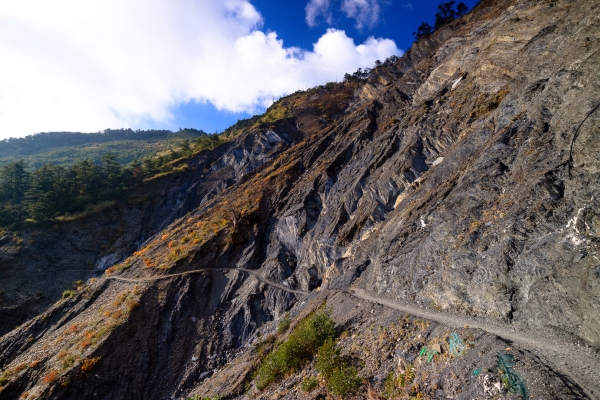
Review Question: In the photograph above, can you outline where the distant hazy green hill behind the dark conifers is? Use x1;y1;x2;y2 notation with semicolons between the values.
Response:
0;129;205;169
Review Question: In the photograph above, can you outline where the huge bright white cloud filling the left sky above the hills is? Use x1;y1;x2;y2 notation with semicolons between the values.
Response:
0;0;401;138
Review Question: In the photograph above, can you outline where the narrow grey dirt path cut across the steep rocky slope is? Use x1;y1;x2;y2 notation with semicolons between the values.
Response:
106;268;600;399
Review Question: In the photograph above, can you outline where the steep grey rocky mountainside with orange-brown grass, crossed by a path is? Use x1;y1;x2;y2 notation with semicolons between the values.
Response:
0;0;600;400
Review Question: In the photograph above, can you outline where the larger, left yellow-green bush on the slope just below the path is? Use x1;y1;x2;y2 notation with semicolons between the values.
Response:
256;309;335;390
